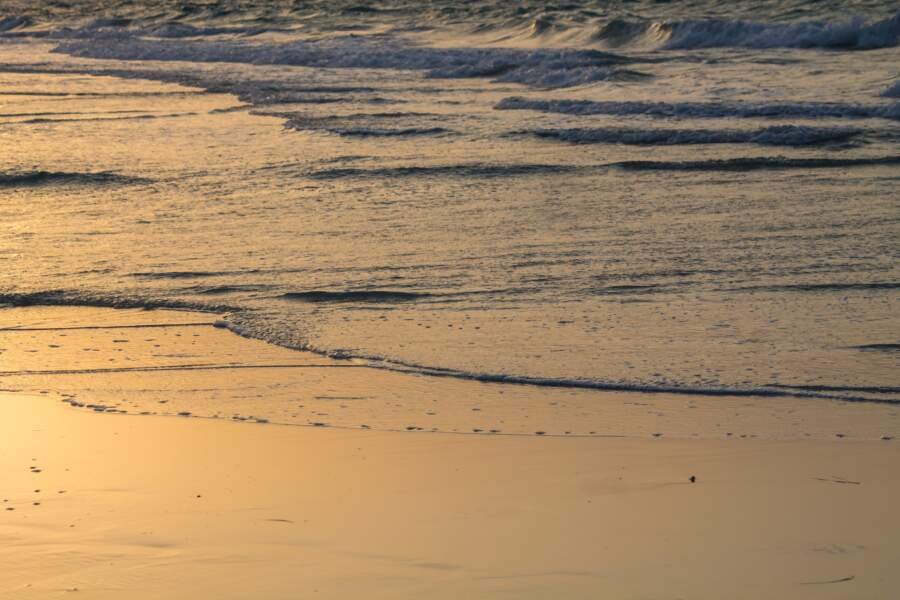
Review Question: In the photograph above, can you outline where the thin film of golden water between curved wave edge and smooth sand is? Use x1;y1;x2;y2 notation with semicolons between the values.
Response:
0;306;900;441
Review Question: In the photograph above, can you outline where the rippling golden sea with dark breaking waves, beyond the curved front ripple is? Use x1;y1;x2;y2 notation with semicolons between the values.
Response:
0;0;900;402
